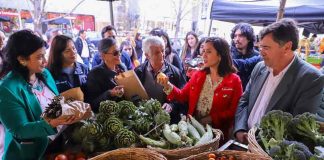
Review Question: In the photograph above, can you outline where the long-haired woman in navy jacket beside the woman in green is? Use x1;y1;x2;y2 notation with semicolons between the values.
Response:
47;35;89;93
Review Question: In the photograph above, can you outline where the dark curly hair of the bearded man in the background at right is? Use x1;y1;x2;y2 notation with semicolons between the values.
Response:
231;23;255;53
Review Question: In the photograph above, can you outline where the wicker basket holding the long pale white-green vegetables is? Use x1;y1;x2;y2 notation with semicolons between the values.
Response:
148;129;223;160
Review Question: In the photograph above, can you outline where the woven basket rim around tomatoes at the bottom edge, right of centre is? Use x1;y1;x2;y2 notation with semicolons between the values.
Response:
181;150;271;160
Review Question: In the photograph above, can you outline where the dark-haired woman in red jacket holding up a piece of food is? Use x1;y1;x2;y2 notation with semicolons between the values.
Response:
157;37;242;140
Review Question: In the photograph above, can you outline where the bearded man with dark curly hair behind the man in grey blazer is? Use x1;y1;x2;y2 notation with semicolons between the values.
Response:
231;23;261;89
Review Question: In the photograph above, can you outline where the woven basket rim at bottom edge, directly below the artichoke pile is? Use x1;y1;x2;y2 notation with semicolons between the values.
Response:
89;148;167;160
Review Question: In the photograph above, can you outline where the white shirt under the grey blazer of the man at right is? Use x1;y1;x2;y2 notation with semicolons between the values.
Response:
248;57;295;128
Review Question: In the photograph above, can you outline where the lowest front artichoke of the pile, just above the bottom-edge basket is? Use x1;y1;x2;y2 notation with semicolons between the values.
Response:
114;129;136;148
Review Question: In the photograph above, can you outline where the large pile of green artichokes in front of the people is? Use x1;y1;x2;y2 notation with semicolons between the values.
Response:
67;99;170;154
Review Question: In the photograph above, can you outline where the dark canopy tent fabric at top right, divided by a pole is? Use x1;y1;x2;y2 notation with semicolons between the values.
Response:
210;0;324;33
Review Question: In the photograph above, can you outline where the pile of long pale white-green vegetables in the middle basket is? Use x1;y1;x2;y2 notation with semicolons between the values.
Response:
139;116;213;149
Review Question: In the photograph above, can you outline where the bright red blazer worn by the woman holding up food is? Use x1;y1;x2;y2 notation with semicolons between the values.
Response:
167;71;243;139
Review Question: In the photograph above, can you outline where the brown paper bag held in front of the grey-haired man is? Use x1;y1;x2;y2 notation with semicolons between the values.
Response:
115;70;148;100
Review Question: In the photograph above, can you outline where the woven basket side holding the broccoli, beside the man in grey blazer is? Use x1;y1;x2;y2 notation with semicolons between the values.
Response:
248;127;269;157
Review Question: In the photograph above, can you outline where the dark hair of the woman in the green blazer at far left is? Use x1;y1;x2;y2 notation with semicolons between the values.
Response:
4;30;46;82
